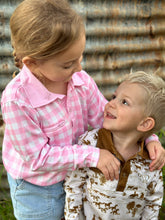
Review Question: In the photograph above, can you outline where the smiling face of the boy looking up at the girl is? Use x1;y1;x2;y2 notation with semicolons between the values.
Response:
103;82;145;133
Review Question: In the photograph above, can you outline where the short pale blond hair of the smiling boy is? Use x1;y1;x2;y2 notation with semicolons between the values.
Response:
124;71;165;137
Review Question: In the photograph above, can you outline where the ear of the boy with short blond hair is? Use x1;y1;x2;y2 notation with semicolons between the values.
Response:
137;117;155;132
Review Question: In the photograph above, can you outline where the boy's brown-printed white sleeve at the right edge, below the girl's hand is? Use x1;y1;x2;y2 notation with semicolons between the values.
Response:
142;170;163;220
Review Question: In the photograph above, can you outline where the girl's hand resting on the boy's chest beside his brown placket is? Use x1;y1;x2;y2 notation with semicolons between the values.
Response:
97;149;120;180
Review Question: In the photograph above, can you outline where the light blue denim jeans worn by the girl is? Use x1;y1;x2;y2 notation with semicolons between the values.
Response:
8;174;65;220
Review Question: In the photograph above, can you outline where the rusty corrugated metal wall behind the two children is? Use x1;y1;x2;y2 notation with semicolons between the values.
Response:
0;0;165;199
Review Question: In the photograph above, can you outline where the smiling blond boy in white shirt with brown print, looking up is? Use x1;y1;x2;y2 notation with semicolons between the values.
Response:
65;72;165;220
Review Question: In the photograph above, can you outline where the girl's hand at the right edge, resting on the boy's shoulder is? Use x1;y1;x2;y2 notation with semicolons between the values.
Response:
147;141;165;171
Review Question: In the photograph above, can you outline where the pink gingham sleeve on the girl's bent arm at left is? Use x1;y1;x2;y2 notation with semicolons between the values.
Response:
3;102;99;174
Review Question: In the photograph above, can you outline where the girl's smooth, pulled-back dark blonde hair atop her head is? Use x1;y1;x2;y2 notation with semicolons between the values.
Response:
10;0;85;59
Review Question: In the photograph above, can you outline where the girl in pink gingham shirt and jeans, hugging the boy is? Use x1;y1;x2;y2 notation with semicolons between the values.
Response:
1;0;164;220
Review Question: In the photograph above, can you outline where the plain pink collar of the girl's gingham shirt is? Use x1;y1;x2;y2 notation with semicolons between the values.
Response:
20;65;83;108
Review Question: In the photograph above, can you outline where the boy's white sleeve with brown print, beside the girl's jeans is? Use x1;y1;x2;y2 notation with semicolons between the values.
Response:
64;168;86;220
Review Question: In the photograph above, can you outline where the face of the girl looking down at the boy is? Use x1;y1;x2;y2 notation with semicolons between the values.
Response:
33;35;85;83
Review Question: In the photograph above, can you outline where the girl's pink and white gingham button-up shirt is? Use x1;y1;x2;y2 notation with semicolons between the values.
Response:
1;66;107;186
